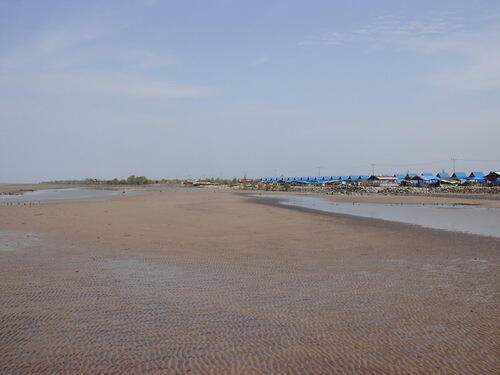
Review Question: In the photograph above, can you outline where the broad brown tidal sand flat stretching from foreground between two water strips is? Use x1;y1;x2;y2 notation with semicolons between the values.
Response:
0;189;500;374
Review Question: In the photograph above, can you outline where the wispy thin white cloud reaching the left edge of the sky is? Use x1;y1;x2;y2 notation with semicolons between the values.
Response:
0;28;212;99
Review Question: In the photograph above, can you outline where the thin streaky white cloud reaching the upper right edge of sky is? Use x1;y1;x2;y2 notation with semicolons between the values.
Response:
300;15;500;91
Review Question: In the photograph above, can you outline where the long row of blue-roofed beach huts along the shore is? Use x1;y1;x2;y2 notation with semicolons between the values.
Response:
260;171;500;186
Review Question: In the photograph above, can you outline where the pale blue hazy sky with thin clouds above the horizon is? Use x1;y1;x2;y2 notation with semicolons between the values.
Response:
0;0;500;182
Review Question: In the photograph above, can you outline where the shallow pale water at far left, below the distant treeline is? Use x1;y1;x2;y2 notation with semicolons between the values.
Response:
0;187;125;205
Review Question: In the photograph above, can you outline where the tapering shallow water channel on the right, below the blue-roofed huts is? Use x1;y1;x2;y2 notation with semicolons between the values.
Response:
253;194;500;237
